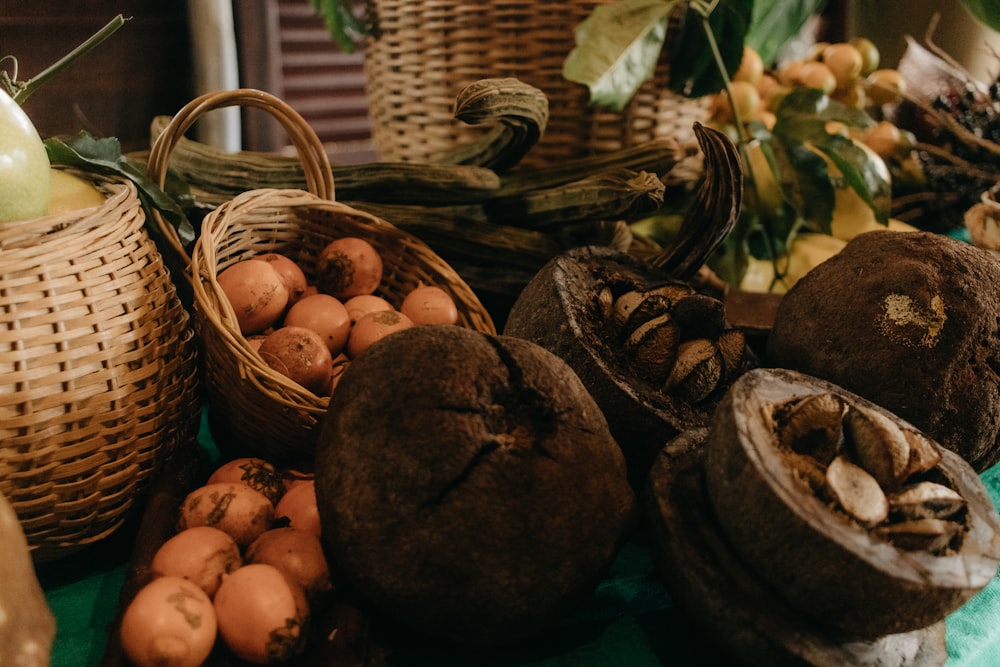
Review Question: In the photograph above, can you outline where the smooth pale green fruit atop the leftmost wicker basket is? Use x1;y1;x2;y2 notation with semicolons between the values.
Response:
0;90;50;222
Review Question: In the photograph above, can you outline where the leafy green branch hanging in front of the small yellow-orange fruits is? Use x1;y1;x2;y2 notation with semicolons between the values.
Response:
563;0;891;284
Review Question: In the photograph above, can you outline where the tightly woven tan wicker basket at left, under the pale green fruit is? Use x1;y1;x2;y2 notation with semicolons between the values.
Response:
0;170;201;562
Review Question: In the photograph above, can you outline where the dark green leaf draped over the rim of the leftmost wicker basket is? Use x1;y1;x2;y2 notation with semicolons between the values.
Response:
45;132;195;245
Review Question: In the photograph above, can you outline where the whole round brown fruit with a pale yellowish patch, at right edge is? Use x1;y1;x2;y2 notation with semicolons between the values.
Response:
766;231;1000;472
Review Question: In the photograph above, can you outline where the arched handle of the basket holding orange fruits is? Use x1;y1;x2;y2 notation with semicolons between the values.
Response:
146;88;334;264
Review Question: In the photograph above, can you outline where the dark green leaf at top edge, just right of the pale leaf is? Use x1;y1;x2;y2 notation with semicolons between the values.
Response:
669;0;754;97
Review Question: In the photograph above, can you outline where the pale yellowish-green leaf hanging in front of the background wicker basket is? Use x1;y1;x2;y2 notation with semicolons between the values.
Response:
563;0;679;111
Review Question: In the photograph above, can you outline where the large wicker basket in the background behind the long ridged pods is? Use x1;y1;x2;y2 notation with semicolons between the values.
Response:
364;0;709;166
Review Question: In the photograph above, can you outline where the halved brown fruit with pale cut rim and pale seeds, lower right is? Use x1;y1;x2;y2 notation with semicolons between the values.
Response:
704;369;1000;640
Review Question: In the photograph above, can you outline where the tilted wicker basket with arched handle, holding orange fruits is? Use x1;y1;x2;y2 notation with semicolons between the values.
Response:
148;89;496;465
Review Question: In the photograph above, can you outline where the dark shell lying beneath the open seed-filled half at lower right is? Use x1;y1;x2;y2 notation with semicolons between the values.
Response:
644;428;948;667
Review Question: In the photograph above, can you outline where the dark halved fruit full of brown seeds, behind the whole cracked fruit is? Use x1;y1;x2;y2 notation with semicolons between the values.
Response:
504;246;757;488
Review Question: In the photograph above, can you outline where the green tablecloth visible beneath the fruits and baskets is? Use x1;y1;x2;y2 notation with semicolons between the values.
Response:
39;428;1000;667
